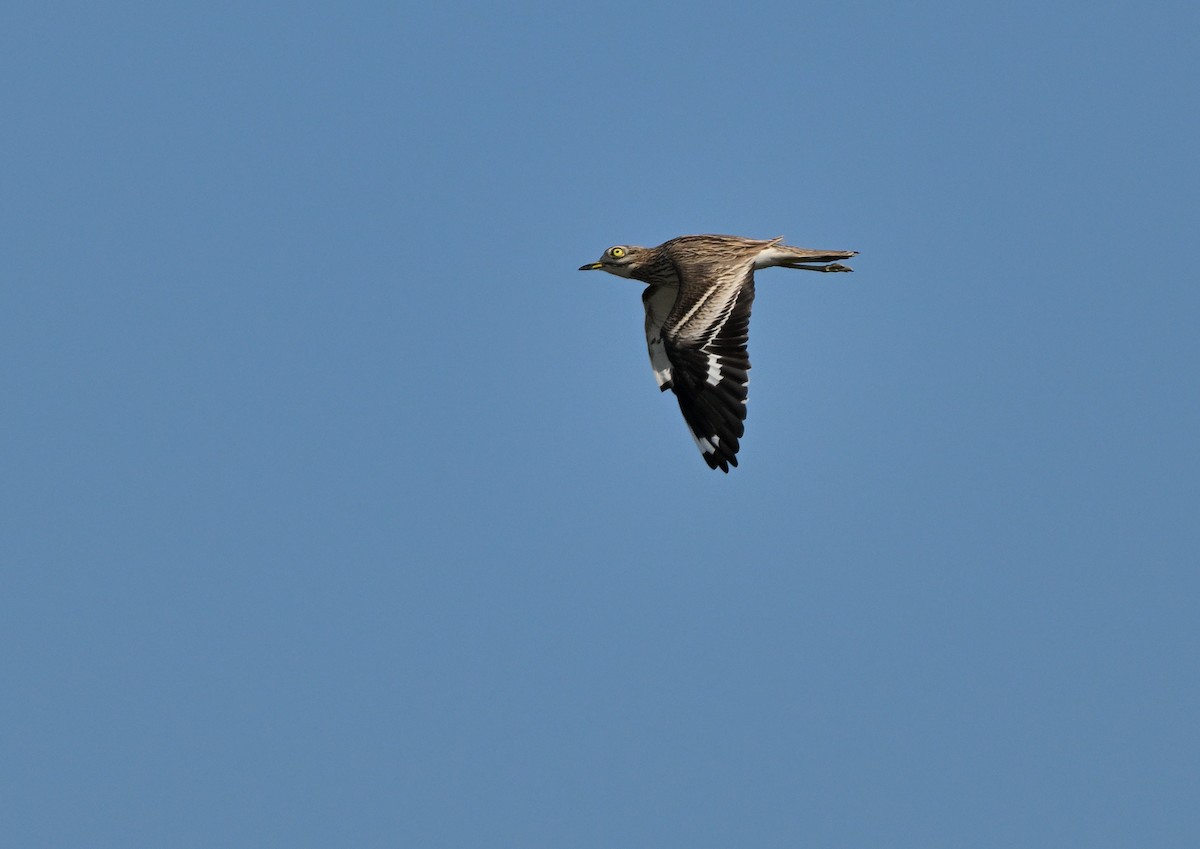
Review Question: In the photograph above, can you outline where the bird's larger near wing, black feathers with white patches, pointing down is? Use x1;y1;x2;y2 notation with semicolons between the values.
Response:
662;257;754;472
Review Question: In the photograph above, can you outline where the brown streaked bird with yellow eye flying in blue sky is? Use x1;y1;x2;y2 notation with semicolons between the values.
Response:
580;234;858;474
